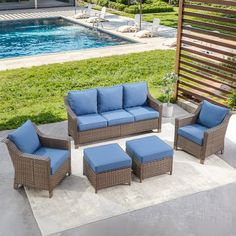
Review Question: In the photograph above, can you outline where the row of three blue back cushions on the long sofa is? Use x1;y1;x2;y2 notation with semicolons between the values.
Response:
67;82;148;116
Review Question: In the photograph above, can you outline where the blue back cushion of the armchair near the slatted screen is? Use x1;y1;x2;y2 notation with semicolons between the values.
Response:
197;100;229;128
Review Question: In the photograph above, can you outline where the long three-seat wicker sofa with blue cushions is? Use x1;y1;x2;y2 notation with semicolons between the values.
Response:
64;82;162;148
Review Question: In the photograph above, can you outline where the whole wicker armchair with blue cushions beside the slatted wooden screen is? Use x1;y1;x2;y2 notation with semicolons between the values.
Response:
174;101;232;164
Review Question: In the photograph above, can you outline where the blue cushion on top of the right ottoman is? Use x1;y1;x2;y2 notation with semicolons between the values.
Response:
126;135;173;164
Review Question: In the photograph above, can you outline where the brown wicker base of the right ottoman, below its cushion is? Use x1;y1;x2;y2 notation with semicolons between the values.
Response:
132;157;173;183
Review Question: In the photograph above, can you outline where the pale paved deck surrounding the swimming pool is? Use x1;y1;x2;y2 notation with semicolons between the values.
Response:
0;7;176;71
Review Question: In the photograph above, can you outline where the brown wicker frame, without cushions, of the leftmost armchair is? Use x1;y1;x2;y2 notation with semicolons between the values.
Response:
2;125;71;198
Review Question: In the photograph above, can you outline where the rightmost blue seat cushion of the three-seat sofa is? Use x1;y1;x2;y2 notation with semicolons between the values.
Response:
125;106;159;121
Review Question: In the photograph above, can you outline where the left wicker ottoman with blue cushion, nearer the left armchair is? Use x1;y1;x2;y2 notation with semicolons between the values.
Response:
83;144;132;193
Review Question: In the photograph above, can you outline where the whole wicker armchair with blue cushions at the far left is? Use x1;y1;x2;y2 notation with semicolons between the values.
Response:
3;120;71;198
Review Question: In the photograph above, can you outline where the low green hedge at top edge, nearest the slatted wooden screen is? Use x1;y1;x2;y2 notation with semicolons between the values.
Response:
124;2;173;14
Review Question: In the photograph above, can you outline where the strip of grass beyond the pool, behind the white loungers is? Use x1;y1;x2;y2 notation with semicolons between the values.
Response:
93;6;178;28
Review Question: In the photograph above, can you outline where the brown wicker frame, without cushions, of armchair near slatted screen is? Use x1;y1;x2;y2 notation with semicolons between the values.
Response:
174;103;232;164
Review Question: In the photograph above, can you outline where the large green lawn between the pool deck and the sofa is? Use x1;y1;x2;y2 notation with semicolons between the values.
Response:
0;50;175;130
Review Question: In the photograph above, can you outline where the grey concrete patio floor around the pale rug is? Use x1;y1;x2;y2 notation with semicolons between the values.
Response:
0;106;236;236
